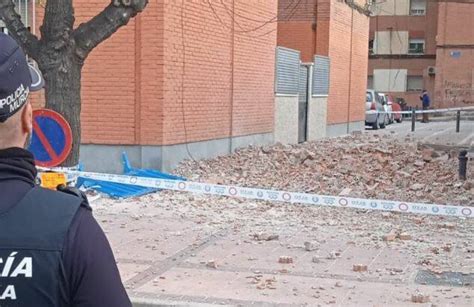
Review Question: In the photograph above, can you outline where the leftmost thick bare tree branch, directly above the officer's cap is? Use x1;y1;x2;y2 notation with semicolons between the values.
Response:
0;0;40;60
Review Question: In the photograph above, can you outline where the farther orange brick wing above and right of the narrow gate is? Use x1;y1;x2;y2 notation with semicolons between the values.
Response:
277;0;369;136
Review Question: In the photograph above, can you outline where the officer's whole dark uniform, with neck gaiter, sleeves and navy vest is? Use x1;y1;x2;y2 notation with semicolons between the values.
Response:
0;148;131;307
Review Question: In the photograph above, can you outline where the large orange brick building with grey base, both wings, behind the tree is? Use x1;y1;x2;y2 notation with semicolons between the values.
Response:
0;0;369;172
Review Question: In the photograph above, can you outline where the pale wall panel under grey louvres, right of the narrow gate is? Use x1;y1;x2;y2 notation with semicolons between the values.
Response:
306;96;328;141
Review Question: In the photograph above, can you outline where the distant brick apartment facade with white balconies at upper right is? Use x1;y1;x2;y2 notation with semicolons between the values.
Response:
367;0;474;108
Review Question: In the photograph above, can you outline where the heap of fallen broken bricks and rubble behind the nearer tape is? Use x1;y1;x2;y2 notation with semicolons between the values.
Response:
177;134;474;205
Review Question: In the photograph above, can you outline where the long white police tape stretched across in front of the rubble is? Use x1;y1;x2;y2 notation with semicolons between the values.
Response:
41;169;474;218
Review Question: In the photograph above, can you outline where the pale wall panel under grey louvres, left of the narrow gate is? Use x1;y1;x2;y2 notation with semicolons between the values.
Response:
274;95;298;144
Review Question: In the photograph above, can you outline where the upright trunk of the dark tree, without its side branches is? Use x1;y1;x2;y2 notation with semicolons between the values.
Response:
36;0;83;166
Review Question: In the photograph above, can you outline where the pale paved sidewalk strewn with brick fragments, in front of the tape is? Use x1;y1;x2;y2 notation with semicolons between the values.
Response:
97;199;474;306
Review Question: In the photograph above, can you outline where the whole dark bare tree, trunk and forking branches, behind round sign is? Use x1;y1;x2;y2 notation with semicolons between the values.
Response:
0;0;148;166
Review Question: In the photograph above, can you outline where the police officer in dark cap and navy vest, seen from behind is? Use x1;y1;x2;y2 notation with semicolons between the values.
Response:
0;34;131;307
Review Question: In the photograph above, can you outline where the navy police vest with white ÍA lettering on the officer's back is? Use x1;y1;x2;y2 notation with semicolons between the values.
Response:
0;187;82;307
